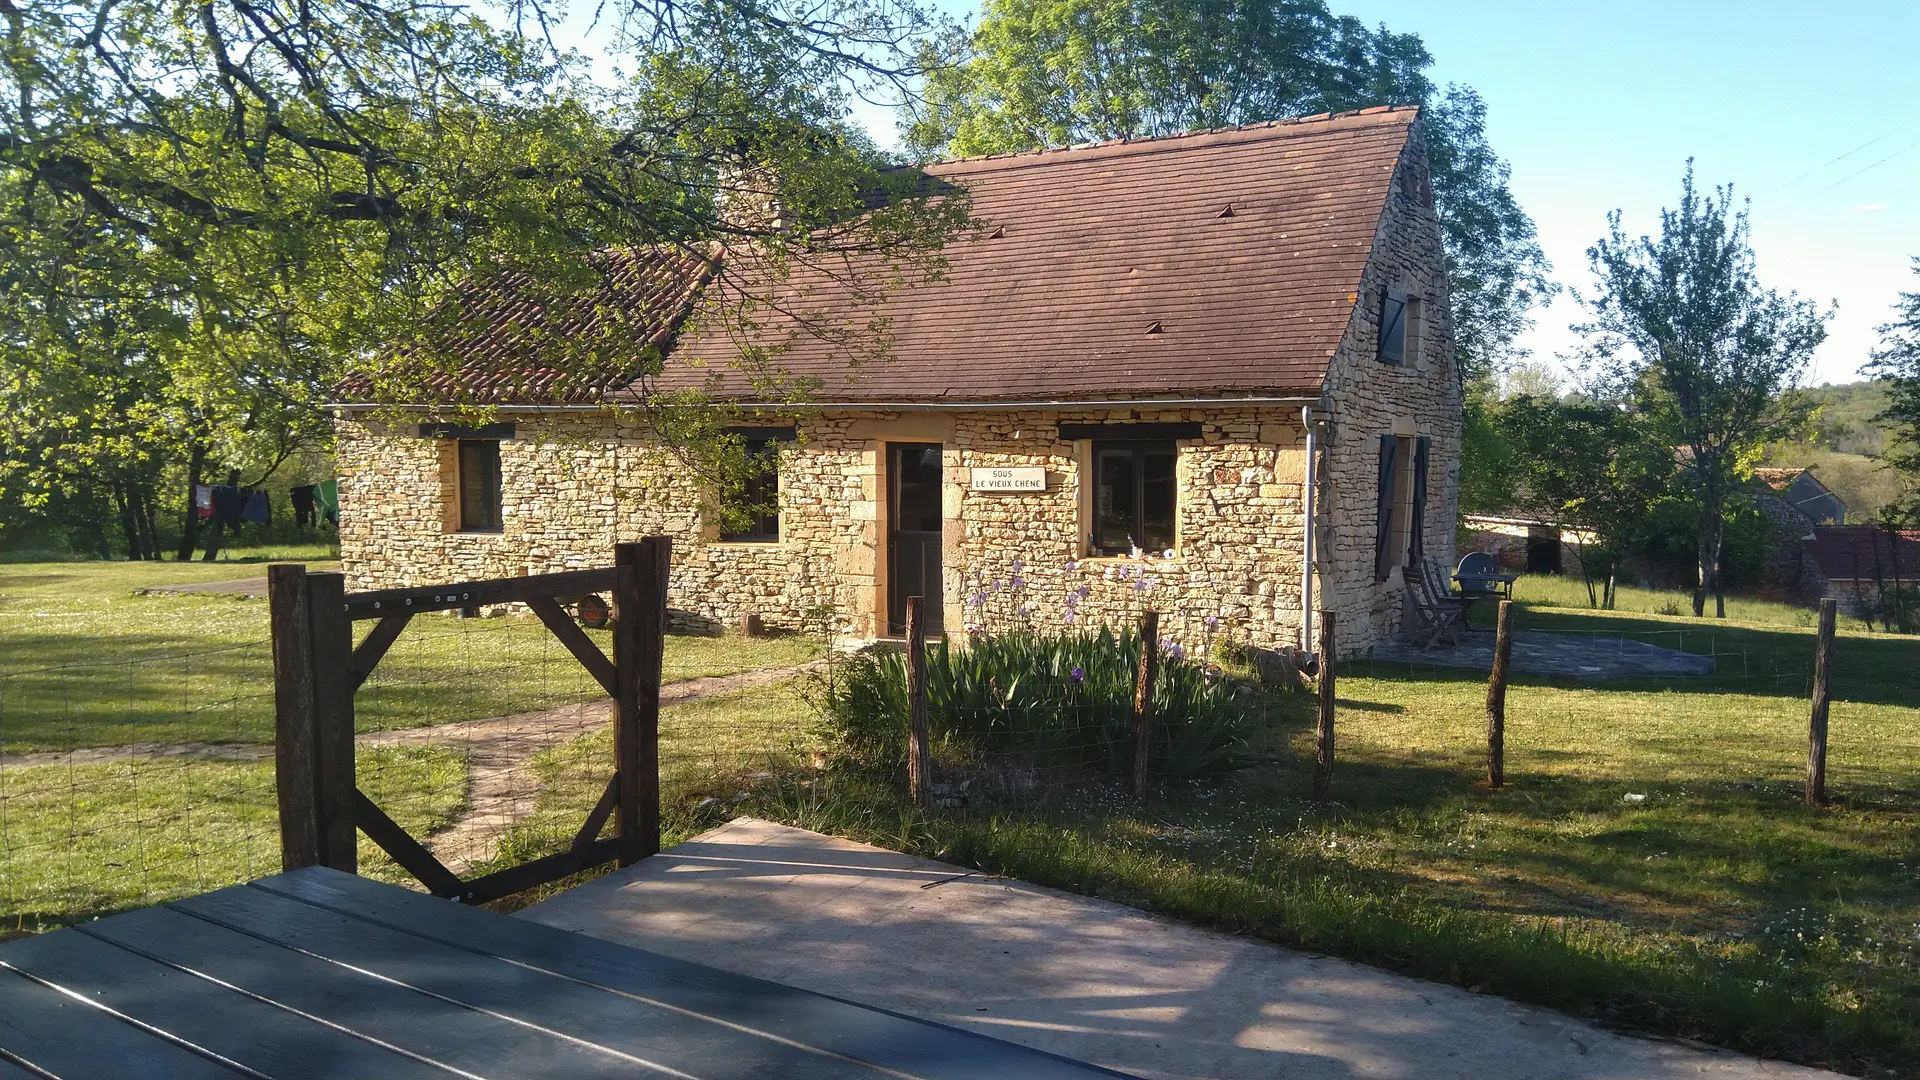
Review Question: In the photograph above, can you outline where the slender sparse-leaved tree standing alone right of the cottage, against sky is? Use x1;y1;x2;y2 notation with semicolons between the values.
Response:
1576;161;1832;619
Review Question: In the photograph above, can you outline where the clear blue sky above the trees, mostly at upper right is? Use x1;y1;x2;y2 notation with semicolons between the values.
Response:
560;0;1920;382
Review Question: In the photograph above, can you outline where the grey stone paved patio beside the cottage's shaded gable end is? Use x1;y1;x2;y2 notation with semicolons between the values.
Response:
1373;630;1713;682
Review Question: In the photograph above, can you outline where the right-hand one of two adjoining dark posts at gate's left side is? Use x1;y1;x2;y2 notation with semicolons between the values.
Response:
307;575;359;874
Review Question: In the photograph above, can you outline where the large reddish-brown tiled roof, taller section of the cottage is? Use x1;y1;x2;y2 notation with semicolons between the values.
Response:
662;108;1417;402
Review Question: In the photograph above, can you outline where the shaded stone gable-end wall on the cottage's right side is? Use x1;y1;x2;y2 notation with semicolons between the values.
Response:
1315;125;1461;653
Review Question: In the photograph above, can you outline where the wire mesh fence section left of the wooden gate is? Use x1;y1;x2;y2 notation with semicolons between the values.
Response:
0;640;280;934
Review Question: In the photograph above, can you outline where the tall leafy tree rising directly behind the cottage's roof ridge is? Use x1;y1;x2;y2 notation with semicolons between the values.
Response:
904;0;1555;382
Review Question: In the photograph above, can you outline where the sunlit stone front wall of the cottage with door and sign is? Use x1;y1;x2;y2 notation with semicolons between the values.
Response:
338;407;1304;648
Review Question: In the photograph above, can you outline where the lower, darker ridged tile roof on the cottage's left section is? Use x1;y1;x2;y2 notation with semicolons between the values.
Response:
334;248;708;405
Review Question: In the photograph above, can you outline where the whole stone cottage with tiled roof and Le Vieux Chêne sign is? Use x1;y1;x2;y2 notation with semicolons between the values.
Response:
334;108;1461;653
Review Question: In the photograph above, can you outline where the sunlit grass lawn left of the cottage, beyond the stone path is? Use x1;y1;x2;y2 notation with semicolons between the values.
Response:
0;563;818;753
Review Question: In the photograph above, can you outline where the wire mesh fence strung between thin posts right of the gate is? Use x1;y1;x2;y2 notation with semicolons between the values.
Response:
798;595;1920;809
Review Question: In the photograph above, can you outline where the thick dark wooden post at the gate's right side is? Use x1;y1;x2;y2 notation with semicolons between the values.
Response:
612;536;674;867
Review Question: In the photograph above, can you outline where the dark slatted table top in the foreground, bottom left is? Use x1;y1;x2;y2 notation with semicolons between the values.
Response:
0;869;1121;1080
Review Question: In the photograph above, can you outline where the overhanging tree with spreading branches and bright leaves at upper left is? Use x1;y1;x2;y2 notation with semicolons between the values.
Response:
0;0;966;552
